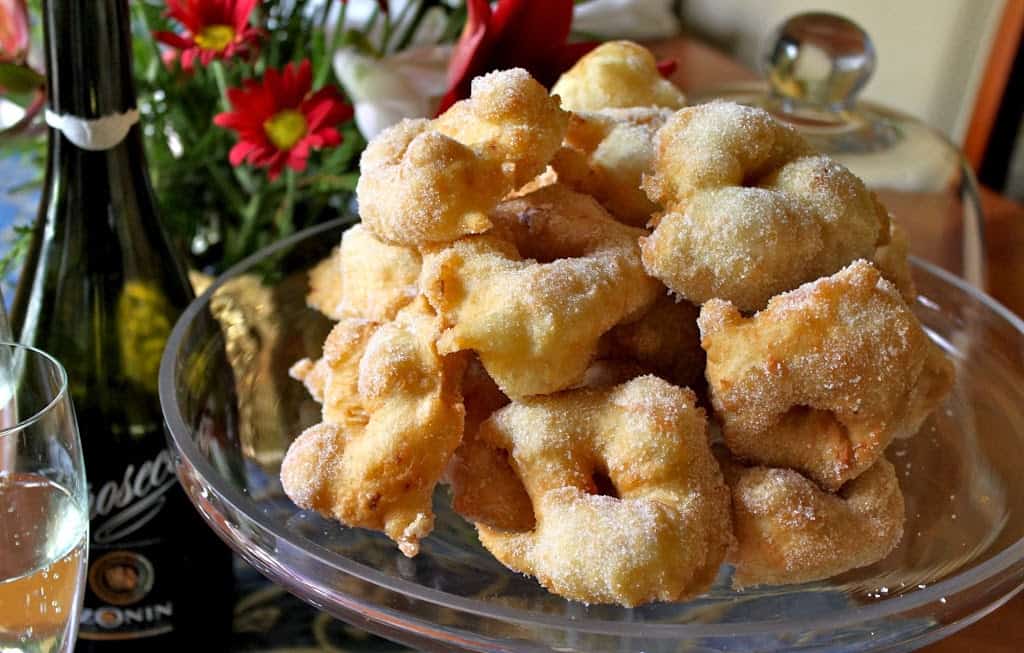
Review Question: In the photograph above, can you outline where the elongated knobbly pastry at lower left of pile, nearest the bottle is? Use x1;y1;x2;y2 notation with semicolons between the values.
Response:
281;300;465;556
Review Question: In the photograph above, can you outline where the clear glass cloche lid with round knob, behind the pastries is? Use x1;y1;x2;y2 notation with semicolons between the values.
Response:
691;12;985;287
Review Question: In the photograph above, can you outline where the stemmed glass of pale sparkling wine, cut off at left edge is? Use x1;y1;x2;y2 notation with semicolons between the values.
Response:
0;342;89;653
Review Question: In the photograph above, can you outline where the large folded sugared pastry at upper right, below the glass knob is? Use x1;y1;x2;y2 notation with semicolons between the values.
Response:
641;101;889;311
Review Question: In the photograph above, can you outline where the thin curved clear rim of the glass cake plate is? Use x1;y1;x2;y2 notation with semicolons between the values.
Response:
159;215;1024;639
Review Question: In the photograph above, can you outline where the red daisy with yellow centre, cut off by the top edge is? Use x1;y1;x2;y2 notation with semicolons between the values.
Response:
153;0;260;71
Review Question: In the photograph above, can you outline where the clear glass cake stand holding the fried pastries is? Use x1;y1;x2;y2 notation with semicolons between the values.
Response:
160;219;1024;653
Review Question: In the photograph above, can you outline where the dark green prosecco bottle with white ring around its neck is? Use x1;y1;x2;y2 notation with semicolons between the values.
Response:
11;0;231;653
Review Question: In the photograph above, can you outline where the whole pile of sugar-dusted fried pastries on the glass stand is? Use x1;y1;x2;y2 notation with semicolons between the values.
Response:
282;42;952;606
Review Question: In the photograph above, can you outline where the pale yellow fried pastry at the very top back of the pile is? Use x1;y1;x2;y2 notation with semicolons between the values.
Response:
551;41;686;112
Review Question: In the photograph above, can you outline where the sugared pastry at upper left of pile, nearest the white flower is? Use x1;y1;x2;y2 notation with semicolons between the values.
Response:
356;69;568;246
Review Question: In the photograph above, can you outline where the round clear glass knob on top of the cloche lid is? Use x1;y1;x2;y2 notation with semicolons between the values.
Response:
762;12;874;112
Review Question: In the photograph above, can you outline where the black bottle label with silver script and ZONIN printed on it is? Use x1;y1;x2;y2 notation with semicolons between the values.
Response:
79;449;177;640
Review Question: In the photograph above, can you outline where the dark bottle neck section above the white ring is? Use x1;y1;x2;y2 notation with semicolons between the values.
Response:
43;0;135;118
